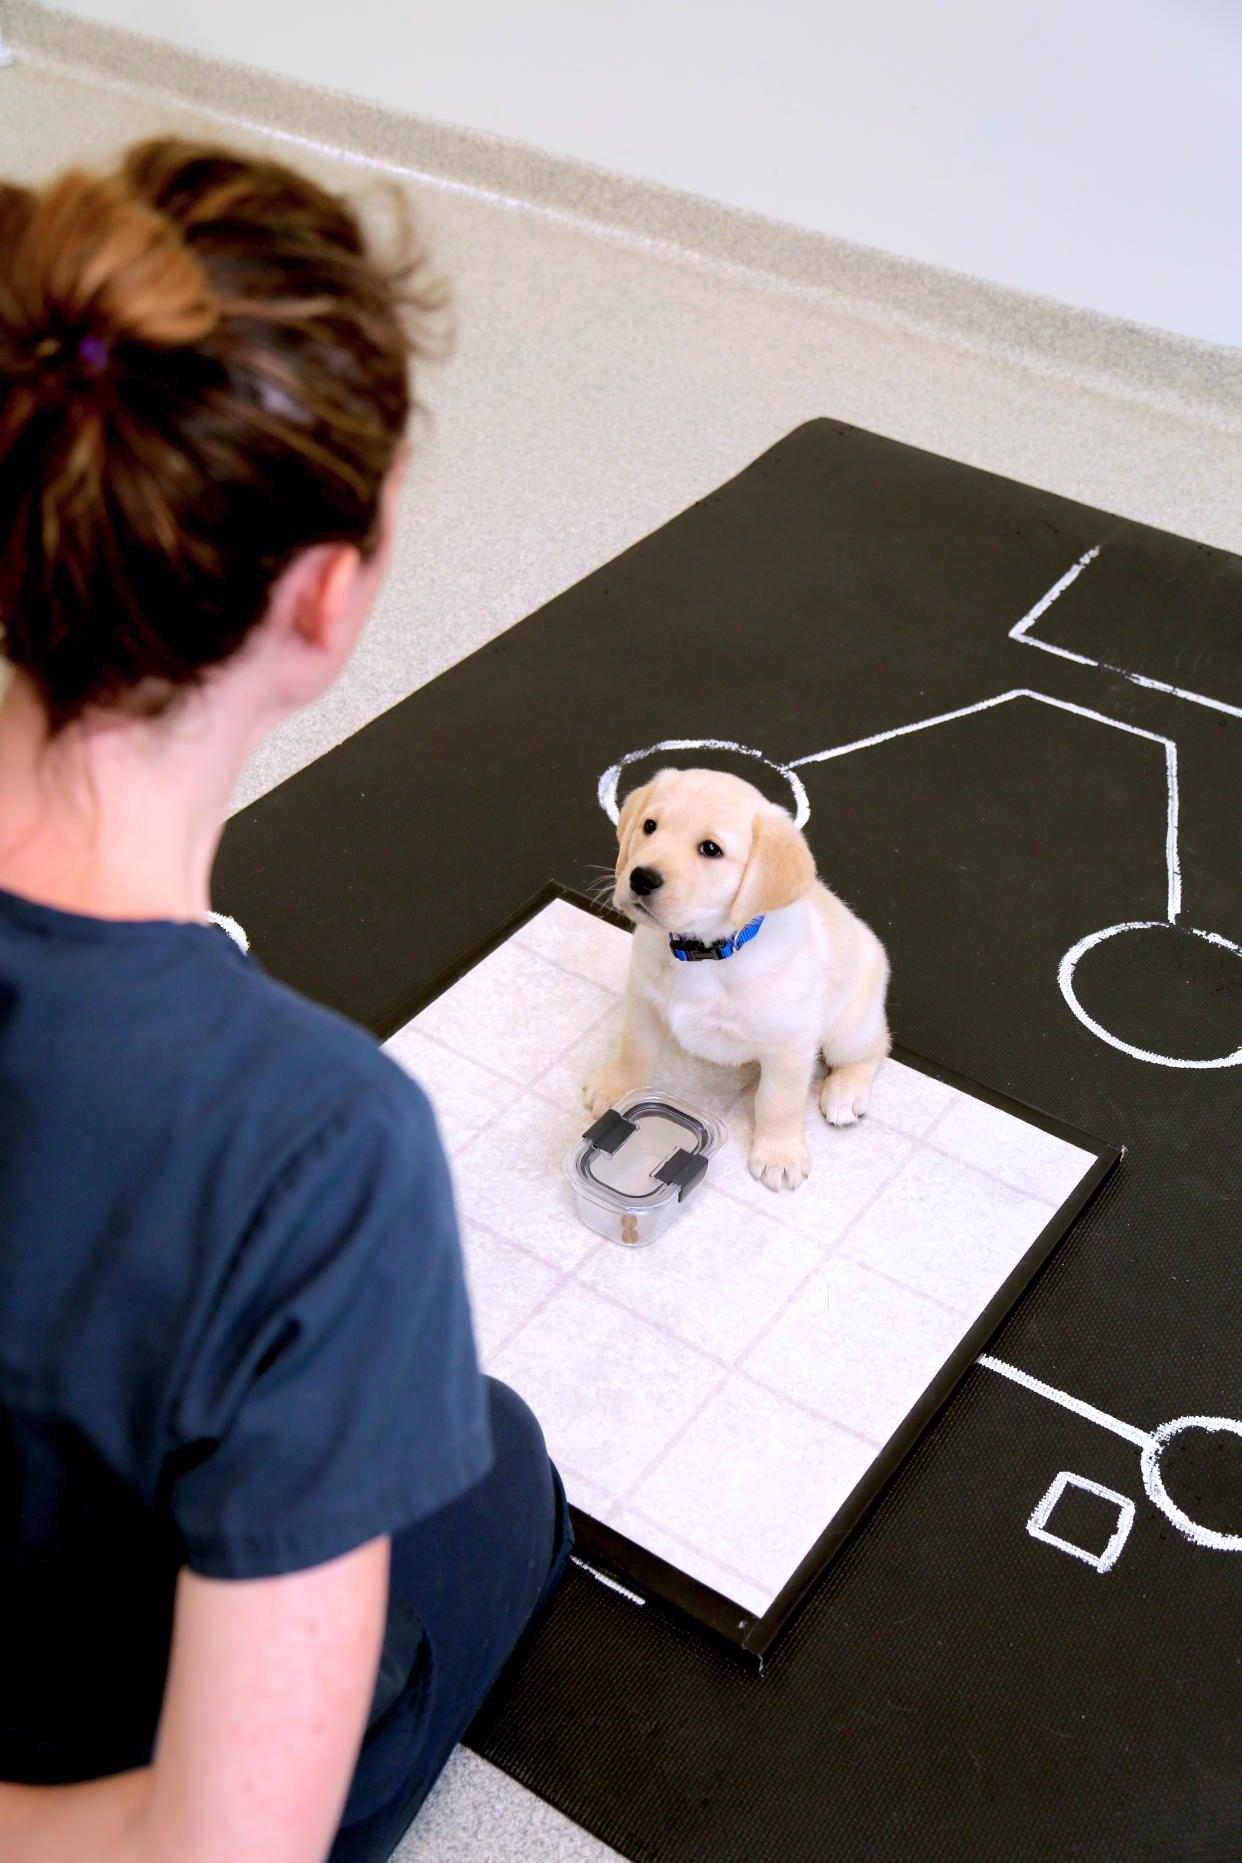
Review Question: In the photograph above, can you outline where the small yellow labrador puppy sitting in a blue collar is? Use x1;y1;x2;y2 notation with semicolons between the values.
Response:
583;769;888;1190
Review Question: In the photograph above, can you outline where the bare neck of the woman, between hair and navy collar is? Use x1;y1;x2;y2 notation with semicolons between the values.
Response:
0;673;258;920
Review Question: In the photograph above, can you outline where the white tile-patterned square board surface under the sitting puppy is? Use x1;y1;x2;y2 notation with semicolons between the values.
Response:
385;900;1095;1617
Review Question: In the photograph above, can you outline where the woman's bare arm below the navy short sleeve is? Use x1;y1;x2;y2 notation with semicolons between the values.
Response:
140;1539;389;1863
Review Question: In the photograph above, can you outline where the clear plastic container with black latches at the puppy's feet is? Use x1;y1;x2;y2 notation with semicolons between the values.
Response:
564;1088;728;1248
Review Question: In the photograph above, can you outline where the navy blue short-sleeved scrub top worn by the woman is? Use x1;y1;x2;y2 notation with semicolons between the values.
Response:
0;892;492;1783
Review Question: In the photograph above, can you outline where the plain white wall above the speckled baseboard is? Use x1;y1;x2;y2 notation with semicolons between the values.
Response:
33;0;1242;343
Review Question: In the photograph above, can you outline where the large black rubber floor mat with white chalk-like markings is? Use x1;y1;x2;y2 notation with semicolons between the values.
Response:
216;421;1242;1863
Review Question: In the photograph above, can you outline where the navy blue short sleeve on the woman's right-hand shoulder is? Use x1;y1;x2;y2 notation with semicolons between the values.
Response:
166;1069;492;1578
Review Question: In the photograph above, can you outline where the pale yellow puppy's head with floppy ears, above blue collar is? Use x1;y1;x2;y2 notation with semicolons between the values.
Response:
613;769;816;945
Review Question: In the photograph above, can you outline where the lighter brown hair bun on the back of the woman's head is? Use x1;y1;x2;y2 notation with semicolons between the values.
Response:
4;170;220;361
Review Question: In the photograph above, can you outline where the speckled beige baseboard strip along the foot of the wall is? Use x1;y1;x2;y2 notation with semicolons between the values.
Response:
9;0;1242;432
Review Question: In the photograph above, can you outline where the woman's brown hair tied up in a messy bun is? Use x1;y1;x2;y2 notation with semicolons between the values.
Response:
0;140;447;732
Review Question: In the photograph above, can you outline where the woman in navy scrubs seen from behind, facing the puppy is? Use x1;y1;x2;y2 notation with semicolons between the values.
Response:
0;142;568;1863
